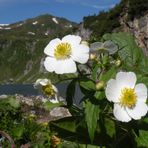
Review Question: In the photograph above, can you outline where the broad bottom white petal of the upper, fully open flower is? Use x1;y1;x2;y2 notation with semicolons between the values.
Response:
55;58;77;74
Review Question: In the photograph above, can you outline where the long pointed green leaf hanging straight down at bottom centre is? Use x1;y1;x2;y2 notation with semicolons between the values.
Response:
84;100;100;142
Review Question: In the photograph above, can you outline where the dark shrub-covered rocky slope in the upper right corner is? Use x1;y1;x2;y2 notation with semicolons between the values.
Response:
83;0;148;55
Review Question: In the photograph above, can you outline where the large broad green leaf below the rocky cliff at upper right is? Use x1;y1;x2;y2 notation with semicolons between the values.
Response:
103;32;144;71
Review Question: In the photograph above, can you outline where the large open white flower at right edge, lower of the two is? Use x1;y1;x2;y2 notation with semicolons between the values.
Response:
105;72;148;122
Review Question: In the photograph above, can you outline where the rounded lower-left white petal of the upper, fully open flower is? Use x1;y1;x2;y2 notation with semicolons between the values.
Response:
44;57;56;72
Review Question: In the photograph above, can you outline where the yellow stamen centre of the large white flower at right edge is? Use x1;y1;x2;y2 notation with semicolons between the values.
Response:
120;88;137;108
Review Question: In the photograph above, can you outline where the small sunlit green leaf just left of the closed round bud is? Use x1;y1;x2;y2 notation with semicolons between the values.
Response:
80;78;96;91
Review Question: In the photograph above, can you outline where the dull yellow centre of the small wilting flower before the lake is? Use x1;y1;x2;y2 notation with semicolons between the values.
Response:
42;84;55;97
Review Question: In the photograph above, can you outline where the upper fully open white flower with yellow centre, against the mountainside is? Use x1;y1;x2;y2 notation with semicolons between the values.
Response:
44;35;89;74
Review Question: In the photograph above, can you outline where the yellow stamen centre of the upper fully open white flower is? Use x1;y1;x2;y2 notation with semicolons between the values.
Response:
54;43;71;60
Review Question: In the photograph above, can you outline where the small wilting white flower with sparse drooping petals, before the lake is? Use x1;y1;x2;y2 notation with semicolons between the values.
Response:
34;79;59;103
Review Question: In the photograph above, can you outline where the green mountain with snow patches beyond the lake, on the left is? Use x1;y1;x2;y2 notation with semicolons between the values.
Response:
0;14;77;83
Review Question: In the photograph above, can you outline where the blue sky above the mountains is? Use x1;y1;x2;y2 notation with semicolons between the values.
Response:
0;0;120;24
